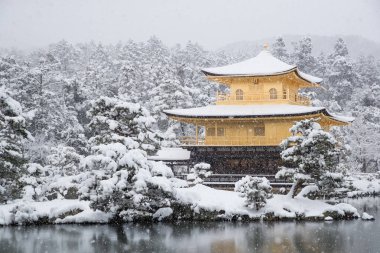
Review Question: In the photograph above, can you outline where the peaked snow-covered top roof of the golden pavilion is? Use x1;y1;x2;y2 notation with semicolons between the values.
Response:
202;50;322;83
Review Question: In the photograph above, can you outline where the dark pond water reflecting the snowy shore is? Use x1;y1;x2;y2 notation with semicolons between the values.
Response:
0;198;380;253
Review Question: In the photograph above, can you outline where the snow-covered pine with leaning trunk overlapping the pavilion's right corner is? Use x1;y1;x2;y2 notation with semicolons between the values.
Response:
276;119;341;198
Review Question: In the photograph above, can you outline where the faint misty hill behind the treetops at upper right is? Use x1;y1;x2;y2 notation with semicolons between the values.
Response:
218;35;380;59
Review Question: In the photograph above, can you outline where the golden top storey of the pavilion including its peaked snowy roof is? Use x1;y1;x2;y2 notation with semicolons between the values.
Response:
202;49;322;105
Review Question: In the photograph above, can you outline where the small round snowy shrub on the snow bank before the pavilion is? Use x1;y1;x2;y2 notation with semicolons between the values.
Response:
235;176;273;210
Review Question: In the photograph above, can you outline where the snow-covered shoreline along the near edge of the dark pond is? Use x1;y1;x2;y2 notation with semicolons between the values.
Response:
0;185;376;225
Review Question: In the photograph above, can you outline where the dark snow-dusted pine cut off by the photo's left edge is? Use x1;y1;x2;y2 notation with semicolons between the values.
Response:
0;87;31;202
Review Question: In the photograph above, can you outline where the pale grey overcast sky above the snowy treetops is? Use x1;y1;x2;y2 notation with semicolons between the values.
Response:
0;0;380;49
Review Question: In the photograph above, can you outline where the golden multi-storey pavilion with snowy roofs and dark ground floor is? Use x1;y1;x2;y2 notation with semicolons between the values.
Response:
164;48;353;174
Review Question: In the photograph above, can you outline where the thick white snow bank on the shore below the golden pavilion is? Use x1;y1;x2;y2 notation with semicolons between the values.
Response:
177;185;359;218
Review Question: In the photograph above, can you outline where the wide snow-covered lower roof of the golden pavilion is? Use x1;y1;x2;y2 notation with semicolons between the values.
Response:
164;104;354;123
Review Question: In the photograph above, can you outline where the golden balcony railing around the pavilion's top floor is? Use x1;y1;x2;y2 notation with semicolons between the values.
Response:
216;92;310;105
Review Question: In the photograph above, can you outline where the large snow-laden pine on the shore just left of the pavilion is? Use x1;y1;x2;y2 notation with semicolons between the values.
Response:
83;97;173;220
